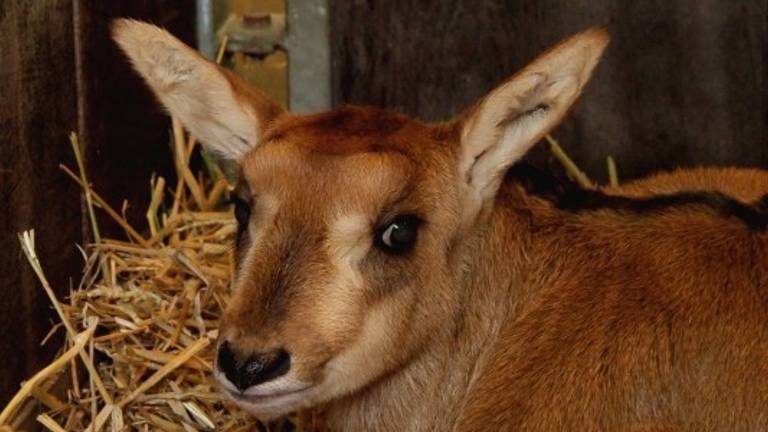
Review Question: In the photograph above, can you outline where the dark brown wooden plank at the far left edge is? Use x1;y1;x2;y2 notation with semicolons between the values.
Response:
0;0;81;406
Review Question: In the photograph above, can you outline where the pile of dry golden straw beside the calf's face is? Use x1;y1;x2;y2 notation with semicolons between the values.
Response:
0;121;314;432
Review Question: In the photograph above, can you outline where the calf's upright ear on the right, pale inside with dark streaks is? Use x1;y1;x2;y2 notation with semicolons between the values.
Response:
458;28;609;219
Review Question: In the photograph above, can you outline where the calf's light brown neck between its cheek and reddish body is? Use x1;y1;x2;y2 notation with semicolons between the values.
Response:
325;197;532;431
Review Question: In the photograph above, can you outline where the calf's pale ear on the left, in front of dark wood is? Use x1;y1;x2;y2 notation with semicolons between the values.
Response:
112;19;283;164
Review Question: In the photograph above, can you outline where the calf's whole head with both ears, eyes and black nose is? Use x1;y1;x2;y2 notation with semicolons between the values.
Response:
113;20;607;417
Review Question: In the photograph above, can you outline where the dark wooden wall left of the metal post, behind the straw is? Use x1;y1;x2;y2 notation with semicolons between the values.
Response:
0;0;194;406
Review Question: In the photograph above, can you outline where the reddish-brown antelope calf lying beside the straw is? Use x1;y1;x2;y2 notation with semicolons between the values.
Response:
114;20;768;431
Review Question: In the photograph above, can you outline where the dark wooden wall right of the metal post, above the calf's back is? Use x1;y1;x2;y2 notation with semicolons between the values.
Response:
331;0;768;182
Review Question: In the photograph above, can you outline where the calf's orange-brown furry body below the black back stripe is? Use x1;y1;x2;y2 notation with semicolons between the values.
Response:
459;176;768;430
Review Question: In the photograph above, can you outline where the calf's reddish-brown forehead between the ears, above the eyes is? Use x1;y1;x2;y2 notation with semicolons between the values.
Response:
241;107;435;218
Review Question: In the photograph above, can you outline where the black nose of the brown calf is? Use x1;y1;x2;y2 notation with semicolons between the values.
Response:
218;342;291;391
